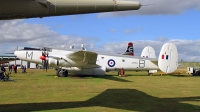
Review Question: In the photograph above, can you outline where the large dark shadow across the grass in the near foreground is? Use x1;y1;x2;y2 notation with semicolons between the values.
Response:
0;89;200;112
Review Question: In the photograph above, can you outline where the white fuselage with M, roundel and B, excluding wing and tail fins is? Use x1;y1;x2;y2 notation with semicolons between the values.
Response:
15;49;159;71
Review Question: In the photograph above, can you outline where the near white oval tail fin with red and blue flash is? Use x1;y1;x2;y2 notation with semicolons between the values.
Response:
158;43;178;73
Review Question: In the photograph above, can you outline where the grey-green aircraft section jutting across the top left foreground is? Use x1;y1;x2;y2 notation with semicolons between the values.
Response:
0;0;141;20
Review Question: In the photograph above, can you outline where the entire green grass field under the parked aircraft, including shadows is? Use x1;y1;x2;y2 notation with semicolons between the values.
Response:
0;70;200;112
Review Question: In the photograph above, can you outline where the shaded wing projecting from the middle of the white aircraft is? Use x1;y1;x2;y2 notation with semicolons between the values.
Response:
66;51;99;68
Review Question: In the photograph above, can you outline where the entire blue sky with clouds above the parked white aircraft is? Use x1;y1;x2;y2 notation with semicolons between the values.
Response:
0;0;200;61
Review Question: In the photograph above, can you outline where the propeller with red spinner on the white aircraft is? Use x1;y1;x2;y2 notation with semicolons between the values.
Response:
40;48;49;72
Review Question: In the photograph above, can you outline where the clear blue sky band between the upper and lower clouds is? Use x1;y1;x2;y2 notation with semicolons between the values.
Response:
24;9;200;44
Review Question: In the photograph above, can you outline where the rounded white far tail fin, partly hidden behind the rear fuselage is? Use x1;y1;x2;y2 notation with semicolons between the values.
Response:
141;46;156;58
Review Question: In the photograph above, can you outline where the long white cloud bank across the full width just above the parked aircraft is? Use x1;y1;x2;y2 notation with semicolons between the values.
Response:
0;20;200;61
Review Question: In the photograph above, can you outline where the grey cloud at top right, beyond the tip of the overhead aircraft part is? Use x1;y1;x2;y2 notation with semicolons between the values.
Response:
97;0;200;18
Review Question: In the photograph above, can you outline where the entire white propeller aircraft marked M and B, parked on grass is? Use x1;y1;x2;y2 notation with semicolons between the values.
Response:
14;43;178;76
